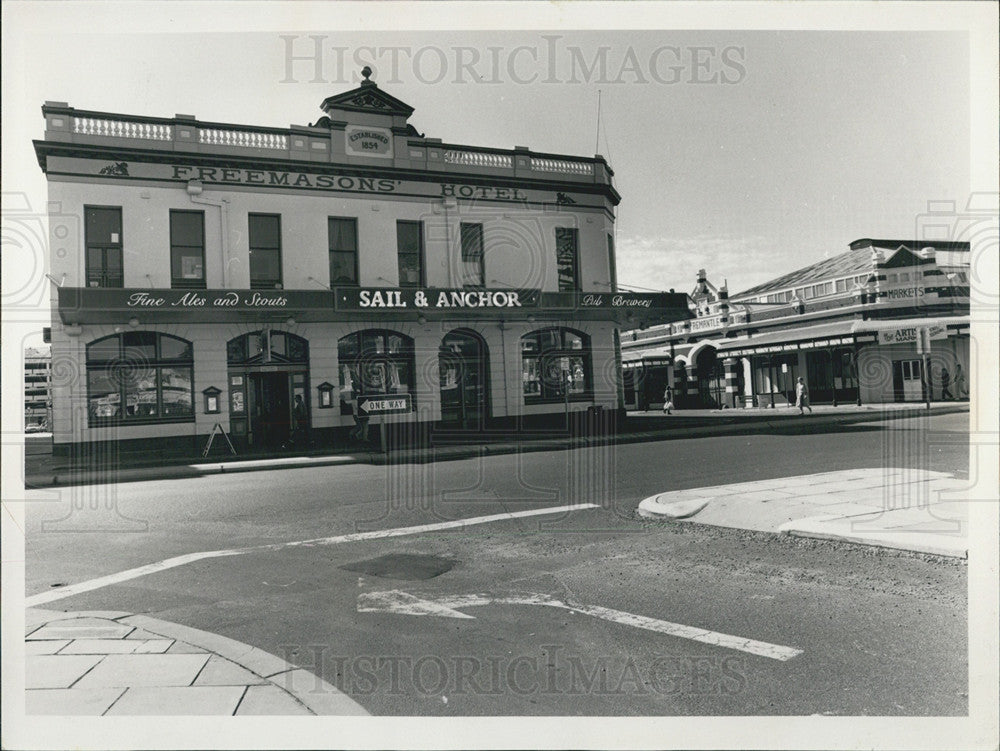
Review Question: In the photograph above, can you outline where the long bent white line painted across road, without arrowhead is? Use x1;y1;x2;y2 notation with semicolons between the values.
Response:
24;503;600;607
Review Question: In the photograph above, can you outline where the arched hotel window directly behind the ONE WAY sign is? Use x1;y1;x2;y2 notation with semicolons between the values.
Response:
337;329;415;415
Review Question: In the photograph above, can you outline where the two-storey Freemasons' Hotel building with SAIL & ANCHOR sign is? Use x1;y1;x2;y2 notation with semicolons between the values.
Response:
34;71;688;451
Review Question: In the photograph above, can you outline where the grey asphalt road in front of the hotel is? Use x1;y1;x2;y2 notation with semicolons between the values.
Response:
26;415;968;715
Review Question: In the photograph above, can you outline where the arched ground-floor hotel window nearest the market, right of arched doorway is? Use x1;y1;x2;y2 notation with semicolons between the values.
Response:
521;328;593;403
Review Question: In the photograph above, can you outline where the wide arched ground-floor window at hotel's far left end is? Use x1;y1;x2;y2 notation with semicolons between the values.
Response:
87;331;194;426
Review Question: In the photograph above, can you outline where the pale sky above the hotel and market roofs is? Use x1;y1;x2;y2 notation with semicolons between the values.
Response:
3;2;988;350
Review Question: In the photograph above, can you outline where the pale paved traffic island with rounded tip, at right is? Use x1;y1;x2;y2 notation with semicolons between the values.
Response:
637;467;969;558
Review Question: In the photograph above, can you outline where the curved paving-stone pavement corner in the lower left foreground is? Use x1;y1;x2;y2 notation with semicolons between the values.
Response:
25;608;368;716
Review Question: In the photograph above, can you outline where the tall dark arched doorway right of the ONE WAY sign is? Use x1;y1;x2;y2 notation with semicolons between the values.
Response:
438;329;489;430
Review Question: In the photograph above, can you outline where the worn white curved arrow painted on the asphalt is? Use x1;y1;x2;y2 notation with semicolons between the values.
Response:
358;589;802;661
